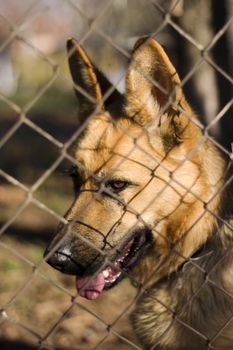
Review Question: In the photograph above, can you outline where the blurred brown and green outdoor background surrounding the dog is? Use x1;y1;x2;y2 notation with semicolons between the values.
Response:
0;0;233;350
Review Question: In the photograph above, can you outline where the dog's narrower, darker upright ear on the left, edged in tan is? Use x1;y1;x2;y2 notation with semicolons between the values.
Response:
67;38;122;119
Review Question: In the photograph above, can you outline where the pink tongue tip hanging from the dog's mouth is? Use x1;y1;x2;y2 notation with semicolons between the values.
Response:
76;272;105;300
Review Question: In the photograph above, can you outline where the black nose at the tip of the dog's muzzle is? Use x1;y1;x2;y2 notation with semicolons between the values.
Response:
44;248;84;276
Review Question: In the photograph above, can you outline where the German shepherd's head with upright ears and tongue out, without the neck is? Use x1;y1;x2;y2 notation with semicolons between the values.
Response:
43;38;223;299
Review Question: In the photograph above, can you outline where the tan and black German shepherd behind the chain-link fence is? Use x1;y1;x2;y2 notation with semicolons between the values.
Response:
45;37;233;350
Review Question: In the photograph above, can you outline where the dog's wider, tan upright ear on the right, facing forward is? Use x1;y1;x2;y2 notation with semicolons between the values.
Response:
126;37;191;133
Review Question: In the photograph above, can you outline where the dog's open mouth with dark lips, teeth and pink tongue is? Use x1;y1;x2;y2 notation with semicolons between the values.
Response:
76;230;151;300
